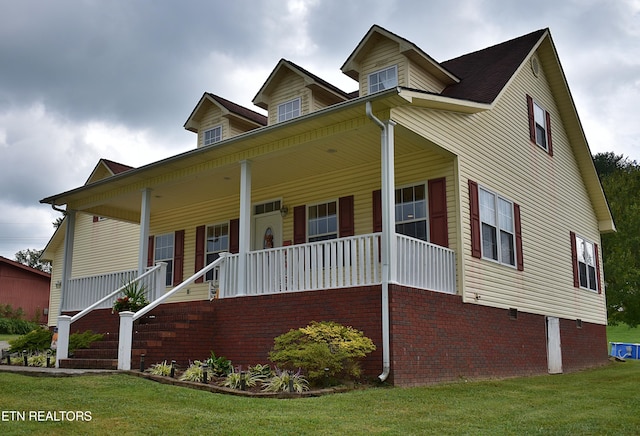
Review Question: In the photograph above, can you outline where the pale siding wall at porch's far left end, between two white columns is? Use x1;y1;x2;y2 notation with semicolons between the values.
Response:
71;213;140;278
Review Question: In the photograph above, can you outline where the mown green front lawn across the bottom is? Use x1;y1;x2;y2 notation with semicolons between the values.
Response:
0;360;640;435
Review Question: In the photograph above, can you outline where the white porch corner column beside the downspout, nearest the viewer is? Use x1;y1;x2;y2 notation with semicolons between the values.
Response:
381;120;397;283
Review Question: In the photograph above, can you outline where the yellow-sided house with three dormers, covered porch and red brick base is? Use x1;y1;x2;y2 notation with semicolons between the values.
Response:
41;25;615;386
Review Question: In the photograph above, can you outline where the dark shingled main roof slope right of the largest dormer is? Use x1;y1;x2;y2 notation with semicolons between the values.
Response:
441;29;548;103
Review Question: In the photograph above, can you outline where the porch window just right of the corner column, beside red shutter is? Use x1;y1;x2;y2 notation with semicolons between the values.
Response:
396;185;428;241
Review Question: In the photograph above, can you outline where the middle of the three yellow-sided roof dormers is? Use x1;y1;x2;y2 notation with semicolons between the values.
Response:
253;59;350;125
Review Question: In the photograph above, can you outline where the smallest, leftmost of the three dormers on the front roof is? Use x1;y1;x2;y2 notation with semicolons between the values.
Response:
184;92;267;147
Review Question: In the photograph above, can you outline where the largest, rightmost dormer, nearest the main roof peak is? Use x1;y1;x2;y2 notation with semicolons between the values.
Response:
341;25;460;96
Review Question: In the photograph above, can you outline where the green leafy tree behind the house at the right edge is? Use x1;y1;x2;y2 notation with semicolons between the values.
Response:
594;152;640;327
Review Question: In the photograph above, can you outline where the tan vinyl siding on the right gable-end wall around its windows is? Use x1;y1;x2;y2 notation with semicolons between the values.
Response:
393;49;606;324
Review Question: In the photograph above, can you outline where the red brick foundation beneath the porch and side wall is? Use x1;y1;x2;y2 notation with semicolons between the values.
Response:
62;285;607;386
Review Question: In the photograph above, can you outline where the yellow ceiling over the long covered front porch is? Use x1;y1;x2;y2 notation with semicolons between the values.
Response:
43;97;448;222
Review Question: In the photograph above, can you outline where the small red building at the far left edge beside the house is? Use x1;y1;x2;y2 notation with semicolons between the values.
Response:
0;256;51;323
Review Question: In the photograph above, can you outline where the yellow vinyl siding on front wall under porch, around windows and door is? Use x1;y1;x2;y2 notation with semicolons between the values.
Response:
151;150;457;301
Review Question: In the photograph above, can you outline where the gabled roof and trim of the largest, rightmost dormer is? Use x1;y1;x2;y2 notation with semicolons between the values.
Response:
340;24;460;84
